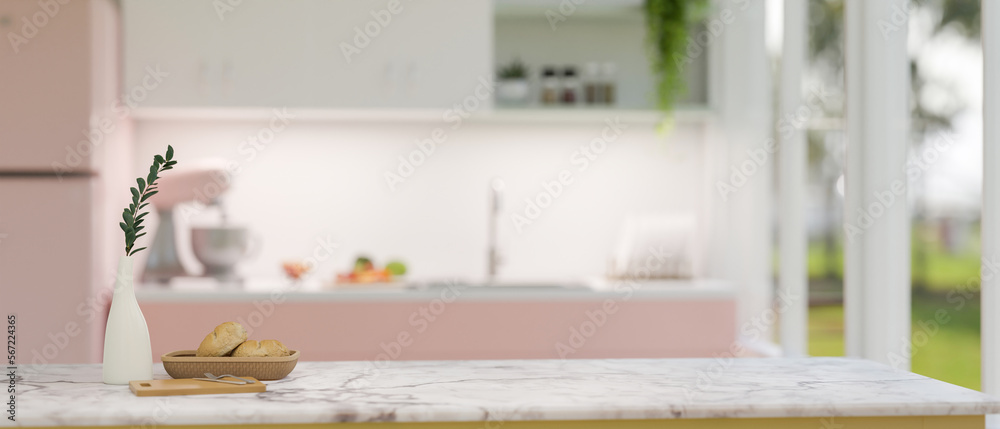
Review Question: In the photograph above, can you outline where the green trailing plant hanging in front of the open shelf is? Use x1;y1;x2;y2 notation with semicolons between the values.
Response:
644;0;708;112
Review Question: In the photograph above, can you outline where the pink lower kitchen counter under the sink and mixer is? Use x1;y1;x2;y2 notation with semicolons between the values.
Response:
136;281;736;361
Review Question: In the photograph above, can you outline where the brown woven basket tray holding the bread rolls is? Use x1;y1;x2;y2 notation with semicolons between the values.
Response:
160;350;299;380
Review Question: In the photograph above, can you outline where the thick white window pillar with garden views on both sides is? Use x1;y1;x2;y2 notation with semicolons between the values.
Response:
844;0;911;370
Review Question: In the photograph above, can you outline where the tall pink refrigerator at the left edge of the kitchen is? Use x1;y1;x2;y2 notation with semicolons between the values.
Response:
0;0;131;364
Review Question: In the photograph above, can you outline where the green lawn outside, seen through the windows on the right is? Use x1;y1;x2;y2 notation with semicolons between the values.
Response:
809;230;980;390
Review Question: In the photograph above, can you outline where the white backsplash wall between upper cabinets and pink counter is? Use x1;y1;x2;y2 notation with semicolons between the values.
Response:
135;112;707;280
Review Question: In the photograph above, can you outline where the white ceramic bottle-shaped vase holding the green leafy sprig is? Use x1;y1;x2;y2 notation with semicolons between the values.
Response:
104;256;153;384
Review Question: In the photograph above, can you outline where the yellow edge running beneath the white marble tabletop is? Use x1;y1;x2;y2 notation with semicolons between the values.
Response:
23;415;986;429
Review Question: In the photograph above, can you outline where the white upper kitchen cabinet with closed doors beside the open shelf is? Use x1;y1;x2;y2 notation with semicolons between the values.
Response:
123;0;493;108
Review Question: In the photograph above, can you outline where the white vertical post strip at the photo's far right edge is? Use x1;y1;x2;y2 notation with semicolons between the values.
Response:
981;0;1000;395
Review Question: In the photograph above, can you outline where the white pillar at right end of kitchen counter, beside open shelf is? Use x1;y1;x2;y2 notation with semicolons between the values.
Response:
717;0;776;344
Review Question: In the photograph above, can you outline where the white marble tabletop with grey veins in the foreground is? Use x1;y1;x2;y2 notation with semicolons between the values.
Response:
5;358;1000;426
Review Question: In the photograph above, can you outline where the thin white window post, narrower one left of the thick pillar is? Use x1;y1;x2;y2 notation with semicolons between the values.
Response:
778;0;809;356
